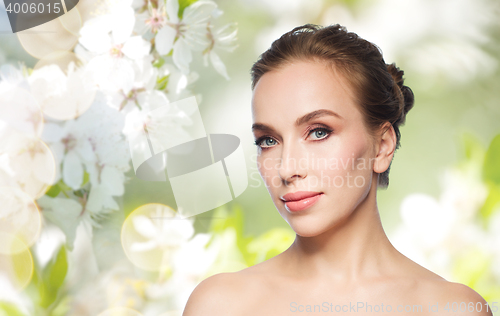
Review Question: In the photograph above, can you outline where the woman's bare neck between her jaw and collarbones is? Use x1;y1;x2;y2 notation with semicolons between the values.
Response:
283;181;401;284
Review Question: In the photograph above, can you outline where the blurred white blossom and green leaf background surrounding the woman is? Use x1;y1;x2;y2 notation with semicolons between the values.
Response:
0;0;500;316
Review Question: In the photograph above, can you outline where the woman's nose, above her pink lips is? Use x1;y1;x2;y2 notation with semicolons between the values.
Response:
278;145;308;185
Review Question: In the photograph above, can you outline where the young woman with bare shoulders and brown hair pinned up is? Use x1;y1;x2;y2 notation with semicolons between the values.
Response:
183;24;492;316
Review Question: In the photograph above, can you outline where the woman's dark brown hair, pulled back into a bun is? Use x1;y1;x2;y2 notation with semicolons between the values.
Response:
251;24;414;188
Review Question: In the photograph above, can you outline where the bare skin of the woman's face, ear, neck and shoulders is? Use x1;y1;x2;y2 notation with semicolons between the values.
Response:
183;61;492;316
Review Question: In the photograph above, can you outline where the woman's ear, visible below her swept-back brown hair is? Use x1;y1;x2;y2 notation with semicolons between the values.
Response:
373;122;396;173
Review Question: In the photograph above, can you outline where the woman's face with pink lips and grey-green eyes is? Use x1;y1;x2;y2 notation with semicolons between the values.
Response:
252;61;377;237
